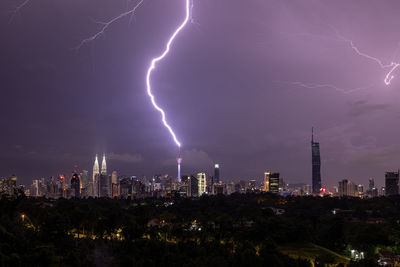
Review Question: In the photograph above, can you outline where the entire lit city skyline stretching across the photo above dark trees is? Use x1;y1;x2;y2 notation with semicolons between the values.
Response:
0;131;399;198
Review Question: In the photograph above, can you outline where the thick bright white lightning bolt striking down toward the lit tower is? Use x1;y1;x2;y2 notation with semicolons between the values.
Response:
146;0;191;148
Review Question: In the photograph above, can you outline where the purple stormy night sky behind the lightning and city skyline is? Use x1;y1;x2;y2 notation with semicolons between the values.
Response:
0;0;400;186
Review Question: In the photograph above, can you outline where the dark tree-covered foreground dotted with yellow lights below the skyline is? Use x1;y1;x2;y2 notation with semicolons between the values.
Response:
0;194;400;266
